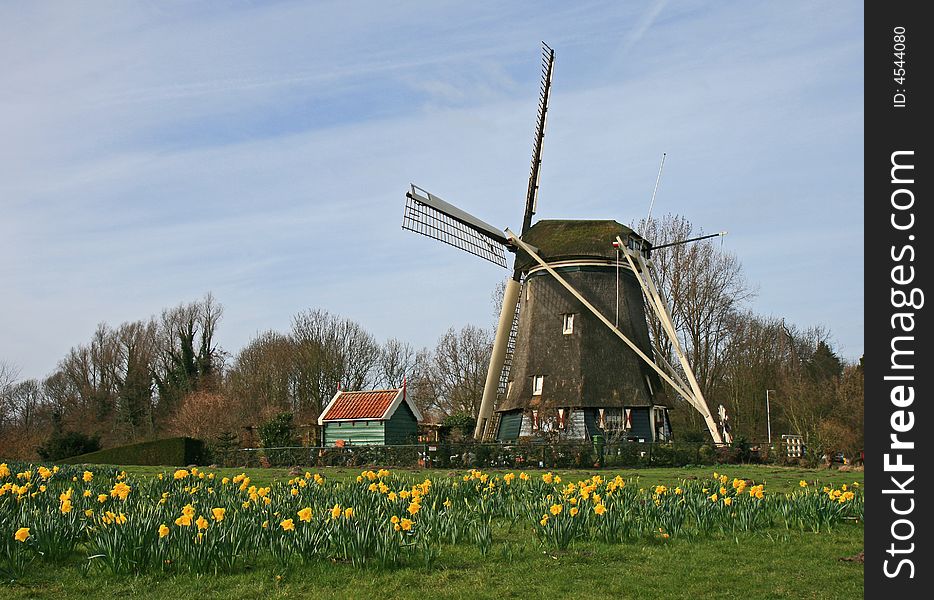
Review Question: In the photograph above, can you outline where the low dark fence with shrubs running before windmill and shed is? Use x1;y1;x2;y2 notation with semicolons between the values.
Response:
214;442;759;469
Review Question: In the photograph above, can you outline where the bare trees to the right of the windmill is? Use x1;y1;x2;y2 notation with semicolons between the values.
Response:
635;215;863;457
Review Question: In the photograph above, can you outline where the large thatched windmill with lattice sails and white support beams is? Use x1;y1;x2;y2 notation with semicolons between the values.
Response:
402;43;722;443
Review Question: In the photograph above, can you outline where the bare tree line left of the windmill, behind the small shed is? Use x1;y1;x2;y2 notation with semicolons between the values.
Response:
0;294;492;458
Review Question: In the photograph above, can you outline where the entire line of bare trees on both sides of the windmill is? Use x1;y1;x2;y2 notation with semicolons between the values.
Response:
0;215;863;458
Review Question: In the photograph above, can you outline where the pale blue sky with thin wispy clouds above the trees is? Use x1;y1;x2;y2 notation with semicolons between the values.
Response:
0;1;863;377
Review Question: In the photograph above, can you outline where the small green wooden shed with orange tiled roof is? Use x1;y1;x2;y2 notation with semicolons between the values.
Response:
318;386;422;446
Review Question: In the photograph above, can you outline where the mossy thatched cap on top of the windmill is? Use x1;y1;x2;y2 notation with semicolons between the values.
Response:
516;219;641;270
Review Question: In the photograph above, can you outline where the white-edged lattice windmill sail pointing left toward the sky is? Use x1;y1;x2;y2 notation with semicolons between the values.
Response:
402;185;510;269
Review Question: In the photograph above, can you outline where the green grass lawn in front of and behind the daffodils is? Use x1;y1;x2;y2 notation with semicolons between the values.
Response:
4;466;863;599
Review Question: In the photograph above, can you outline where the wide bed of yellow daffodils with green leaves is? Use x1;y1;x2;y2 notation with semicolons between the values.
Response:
0;464;864;578
